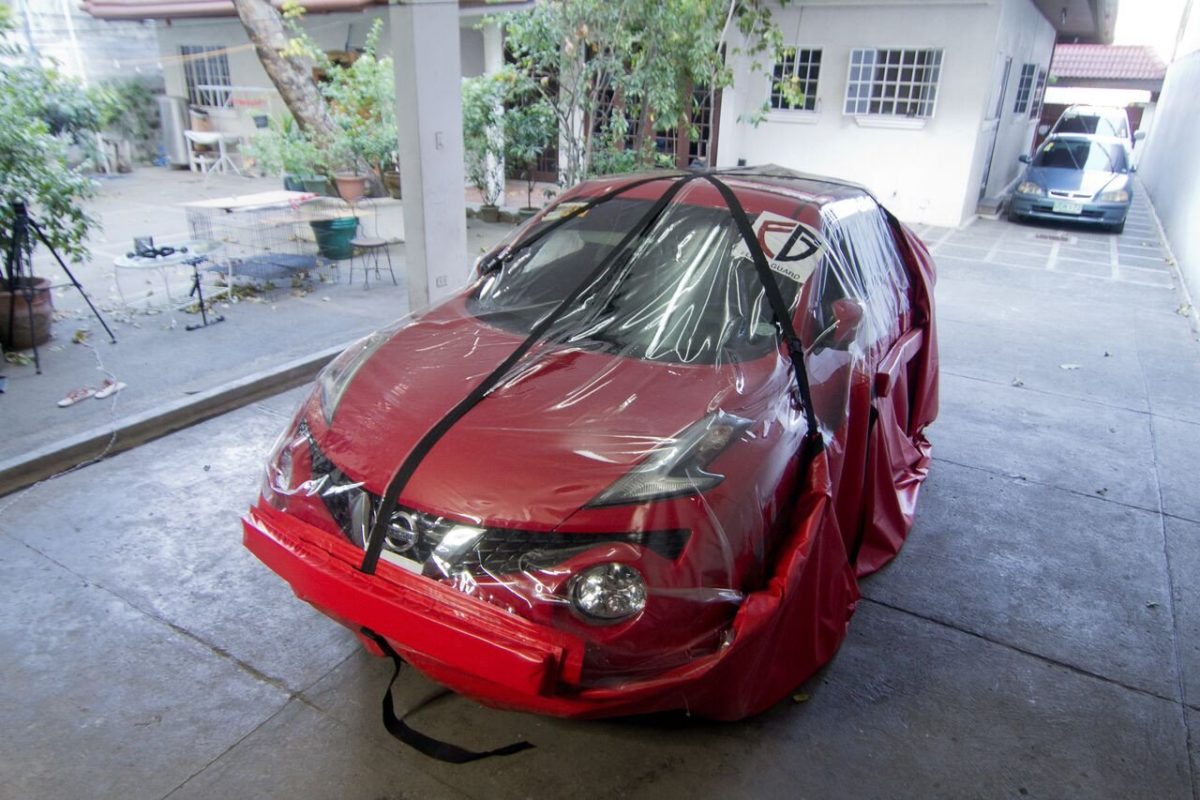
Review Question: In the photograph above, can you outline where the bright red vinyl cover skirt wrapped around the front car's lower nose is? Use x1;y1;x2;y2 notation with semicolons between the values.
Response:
242;472;858;720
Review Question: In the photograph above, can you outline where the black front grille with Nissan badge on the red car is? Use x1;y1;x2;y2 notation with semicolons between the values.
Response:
298;422;690;575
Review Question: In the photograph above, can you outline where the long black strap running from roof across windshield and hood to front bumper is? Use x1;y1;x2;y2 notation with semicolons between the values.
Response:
359;175;696;575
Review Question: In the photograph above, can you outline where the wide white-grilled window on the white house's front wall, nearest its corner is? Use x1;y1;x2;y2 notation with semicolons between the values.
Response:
845;49;942;119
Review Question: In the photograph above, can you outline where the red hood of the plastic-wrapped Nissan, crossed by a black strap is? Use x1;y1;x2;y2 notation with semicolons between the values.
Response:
318;300;778;529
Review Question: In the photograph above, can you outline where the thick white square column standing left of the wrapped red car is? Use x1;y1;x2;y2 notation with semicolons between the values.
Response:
388;0;470;311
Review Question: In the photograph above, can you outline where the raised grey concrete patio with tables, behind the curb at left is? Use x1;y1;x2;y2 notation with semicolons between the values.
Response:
0;167;511;474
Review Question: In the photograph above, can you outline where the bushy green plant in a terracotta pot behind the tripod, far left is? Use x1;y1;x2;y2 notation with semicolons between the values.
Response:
0;6;98;348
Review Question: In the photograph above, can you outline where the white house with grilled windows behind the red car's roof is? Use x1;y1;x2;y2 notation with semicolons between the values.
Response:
715;0;1117;225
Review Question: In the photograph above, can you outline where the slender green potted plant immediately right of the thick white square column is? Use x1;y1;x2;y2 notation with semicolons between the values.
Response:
453;73;505;222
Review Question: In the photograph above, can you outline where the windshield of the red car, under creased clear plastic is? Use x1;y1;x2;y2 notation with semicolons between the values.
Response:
468;190;799;363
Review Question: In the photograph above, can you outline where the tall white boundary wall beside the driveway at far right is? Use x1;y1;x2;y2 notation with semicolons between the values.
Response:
1138;7;1200;301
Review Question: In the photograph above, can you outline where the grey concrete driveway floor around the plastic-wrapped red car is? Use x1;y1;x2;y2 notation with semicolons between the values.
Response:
0;191;1200;800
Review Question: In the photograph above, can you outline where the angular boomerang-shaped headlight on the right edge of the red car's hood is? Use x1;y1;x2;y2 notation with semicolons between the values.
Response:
588;411;752;509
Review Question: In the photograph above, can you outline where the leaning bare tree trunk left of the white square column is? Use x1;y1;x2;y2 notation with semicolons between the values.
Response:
233;0;334;142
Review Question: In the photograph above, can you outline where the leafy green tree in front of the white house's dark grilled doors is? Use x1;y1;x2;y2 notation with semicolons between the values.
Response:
502;0;796;185
